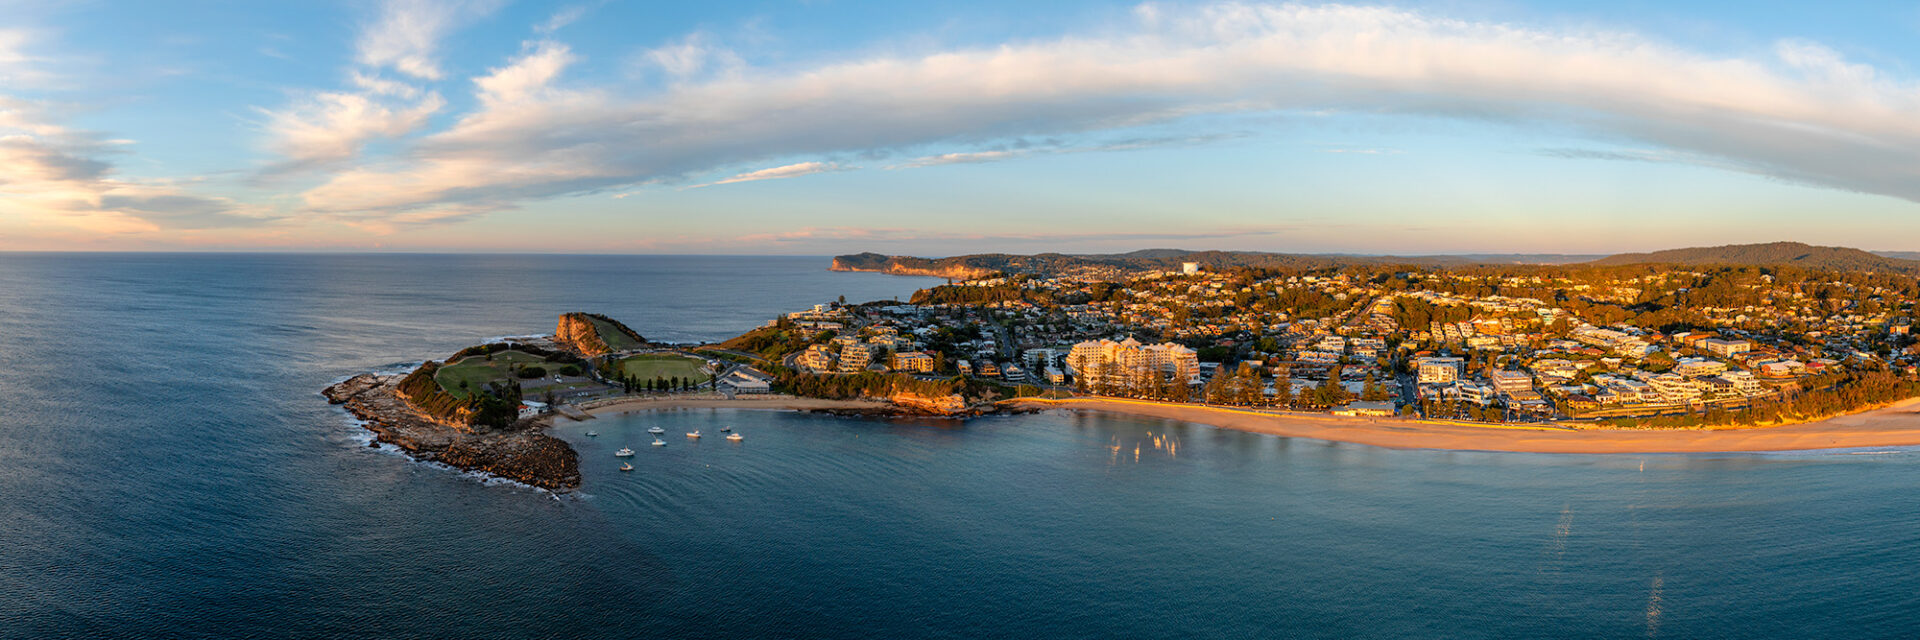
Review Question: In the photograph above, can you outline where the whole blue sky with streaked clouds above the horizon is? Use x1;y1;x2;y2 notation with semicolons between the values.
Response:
0;0;1920;256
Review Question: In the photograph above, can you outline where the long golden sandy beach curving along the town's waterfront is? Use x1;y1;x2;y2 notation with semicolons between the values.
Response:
1016;398;1920;454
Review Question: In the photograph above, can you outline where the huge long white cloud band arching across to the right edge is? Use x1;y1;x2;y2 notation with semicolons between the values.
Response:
280;4;1920;226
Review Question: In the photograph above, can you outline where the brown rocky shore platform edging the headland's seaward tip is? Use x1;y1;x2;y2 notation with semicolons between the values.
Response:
321;373;580;490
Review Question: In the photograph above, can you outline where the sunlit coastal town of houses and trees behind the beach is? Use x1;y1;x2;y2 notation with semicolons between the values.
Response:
749;257;1920;427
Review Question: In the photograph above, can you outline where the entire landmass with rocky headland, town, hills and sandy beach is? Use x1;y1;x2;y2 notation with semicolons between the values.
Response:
324;242;1920;490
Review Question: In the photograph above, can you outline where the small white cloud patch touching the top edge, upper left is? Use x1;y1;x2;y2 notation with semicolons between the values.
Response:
357;0;499;81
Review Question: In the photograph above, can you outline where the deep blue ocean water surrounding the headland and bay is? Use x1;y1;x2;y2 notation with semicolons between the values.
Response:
0;254;1920;638
